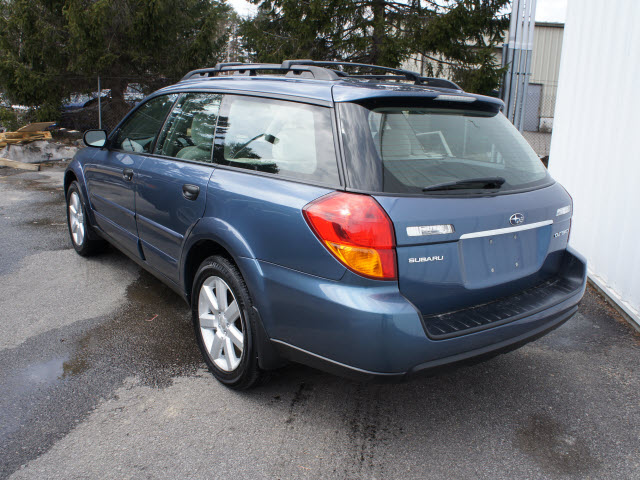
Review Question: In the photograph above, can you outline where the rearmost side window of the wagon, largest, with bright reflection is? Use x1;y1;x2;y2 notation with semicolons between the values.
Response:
214;95;340;185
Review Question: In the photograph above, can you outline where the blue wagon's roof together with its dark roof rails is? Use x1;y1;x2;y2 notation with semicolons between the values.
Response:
152;60;502;106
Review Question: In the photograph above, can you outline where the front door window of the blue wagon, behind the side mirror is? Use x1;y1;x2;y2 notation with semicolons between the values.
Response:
111;94;178;153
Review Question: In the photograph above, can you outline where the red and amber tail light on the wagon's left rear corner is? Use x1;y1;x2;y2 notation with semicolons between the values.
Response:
302;192;397;280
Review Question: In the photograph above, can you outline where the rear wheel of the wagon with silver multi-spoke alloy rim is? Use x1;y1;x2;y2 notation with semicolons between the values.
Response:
191;255;263;390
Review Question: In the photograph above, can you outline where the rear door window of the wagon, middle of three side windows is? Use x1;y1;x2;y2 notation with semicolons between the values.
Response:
155;93;222;162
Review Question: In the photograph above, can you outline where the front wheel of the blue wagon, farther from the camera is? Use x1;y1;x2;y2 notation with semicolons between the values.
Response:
67;181;106;257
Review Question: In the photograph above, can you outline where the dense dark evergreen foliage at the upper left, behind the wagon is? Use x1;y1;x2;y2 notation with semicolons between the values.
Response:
0;0;230;119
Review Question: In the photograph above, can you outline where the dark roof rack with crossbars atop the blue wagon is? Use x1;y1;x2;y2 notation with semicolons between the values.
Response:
180;60;462;90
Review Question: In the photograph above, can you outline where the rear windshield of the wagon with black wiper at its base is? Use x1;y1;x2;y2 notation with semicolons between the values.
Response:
339;103;551;195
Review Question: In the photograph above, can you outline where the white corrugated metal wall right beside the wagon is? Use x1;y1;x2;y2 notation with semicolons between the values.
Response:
549;0;640;324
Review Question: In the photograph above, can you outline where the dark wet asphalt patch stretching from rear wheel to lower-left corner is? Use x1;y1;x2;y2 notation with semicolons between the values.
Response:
0;264;202;478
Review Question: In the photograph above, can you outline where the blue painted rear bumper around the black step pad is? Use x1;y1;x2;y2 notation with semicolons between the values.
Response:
241;251;586;382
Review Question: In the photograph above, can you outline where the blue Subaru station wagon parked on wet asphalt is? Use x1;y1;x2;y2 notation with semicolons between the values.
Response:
64;60;586;389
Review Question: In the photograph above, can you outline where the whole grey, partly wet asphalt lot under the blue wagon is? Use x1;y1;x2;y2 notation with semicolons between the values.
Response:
0;167;640;479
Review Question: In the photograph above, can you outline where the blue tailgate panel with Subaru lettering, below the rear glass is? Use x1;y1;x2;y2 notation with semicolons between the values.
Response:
376;184;571;315
